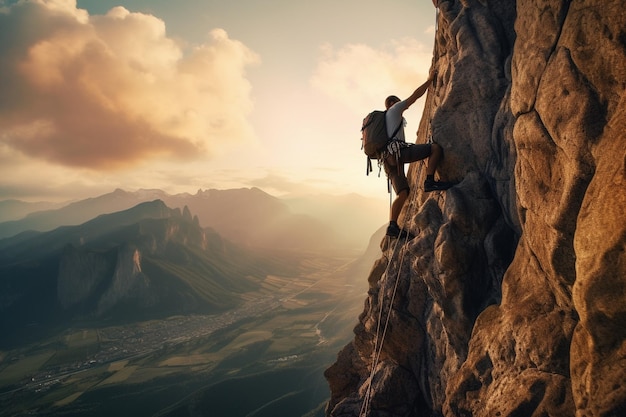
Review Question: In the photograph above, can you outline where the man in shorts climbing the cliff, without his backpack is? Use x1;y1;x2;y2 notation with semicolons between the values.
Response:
382;72;454;237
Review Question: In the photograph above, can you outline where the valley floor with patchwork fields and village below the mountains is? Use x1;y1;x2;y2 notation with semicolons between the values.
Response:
0;252;367;417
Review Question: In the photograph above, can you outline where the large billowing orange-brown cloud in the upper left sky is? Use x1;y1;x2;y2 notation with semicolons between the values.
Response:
0;0;259;170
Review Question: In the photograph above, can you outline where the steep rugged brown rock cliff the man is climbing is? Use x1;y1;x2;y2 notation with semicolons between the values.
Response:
326;0;626;417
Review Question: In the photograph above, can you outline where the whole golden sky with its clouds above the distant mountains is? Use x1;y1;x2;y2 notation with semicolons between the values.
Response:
0;0;436;201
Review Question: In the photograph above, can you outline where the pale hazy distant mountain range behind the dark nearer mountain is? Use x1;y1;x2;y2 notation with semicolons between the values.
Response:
0;188;387;250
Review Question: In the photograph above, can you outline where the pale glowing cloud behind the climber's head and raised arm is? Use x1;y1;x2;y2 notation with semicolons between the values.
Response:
311;38;432;113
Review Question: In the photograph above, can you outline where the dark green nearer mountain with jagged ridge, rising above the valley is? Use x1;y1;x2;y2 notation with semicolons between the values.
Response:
0;200;297;346
